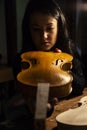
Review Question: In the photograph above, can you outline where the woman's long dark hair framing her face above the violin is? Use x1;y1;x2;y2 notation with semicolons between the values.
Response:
22;0;78;55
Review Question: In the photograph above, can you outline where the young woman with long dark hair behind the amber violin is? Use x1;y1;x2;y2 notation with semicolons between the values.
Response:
14;0;85;116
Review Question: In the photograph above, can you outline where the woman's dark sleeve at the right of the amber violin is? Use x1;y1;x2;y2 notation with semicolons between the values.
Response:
72;58;86;95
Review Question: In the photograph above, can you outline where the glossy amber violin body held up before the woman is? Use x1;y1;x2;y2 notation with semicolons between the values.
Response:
17;51;73;97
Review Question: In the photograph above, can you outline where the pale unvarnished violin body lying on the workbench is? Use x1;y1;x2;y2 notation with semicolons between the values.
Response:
56;96;87;130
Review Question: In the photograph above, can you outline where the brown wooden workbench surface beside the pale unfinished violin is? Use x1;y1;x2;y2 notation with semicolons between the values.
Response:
46;88;87;130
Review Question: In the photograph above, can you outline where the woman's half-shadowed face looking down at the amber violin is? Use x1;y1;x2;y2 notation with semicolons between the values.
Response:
30;13;58;51
